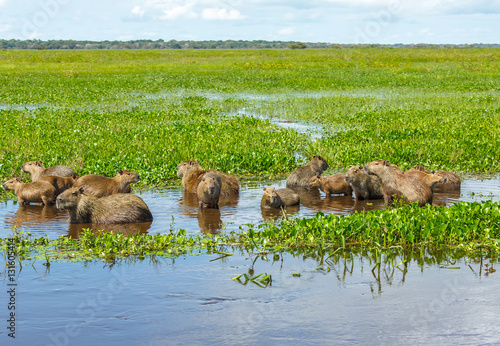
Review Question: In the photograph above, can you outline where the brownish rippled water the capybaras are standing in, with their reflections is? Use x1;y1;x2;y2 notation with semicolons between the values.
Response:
0;177;500;238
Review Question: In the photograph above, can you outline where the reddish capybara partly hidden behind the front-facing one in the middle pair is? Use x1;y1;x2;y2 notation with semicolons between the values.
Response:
177;161;240;197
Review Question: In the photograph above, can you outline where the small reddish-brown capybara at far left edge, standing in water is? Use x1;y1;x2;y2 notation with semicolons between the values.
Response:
2;178;56;205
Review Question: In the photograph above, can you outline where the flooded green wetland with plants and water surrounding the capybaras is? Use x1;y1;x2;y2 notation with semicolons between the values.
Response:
0;48;500;345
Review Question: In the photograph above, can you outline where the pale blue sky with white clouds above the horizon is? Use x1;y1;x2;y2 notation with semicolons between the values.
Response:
0;0;500;44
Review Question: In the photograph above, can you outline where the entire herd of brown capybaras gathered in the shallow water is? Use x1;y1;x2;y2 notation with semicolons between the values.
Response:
3;156;460;224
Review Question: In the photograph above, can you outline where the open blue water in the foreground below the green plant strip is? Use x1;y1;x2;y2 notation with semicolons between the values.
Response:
0;249;500;345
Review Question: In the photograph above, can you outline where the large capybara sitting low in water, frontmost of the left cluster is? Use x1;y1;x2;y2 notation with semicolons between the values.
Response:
56;187;153;223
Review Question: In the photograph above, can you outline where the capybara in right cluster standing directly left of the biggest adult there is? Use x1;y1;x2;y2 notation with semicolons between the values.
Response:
345;166;384;200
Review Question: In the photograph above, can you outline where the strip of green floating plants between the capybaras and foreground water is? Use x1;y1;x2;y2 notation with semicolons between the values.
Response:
2;201;500;261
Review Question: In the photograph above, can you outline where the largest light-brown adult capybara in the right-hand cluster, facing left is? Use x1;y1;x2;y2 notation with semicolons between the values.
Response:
364;160;432;206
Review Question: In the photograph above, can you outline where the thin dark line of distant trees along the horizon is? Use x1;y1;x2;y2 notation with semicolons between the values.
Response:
0;39;500;49
